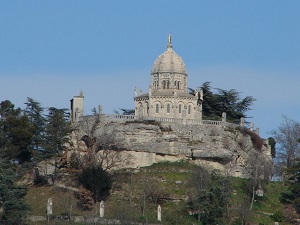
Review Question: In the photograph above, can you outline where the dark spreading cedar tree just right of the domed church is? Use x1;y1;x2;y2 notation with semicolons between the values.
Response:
200;82;255;123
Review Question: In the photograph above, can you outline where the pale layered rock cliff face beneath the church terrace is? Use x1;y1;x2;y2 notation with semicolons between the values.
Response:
85;122;271;177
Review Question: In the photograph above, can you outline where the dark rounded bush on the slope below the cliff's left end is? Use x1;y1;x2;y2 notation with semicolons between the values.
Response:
78;166;113;202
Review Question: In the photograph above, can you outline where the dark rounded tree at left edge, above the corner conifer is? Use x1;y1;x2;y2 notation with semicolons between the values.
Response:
0;100;35;163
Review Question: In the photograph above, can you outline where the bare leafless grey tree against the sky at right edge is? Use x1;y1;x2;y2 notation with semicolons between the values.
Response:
272;116;300;168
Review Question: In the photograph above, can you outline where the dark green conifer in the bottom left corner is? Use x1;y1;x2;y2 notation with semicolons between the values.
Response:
0;160;28;225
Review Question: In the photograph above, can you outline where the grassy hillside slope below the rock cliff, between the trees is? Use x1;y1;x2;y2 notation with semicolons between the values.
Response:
26;161;291;225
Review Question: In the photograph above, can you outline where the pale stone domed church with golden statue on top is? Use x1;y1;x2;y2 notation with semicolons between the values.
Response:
134;35;203;120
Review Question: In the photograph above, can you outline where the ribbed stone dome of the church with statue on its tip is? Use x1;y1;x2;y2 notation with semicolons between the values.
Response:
152;37;186;74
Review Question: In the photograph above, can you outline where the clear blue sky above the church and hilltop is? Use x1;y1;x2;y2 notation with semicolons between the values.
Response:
0;0;300;137
